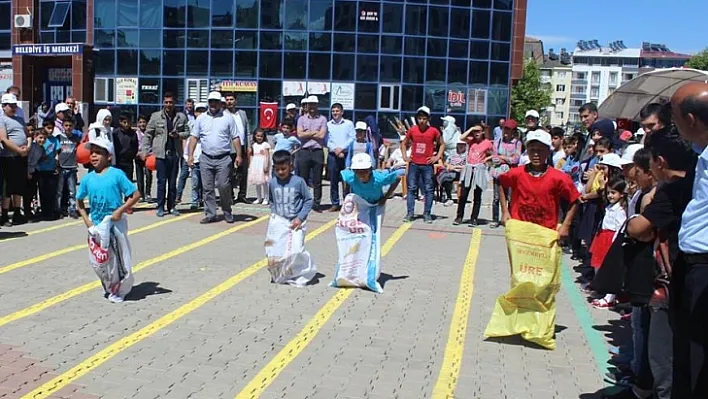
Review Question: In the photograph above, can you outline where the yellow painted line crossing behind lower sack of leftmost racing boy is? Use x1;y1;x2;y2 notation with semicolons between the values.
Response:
0;216;269;327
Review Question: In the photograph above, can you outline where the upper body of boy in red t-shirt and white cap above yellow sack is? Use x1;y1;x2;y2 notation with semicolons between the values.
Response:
499;130;580;239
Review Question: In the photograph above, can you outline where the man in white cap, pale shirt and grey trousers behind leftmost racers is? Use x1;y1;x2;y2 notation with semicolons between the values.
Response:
187;91;241;224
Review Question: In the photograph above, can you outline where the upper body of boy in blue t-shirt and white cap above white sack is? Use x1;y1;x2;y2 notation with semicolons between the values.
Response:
341;152;401;205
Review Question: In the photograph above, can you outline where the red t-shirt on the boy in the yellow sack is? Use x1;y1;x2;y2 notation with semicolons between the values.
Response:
499;166;580;230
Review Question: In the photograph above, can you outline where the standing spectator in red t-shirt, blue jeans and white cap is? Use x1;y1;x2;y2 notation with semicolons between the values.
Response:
401;106;445;223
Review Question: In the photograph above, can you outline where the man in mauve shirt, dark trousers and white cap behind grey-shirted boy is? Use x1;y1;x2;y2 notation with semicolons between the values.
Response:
297;96;327;212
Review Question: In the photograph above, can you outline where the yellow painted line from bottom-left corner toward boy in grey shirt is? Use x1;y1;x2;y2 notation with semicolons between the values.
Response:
22;216;336;399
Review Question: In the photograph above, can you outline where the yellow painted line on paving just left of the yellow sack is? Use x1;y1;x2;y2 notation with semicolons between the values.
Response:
432;229;482;399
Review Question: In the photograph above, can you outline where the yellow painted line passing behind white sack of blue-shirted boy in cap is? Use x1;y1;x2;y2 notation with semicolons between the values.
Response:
236;223;411;399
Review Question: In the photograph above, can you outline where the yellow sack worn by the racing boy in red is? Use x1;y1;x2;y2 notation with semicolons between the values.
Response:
484;220;561;349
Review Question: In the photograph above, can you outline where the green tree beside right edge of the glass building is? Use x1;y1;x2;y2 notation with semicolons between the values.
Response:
511;58;551;122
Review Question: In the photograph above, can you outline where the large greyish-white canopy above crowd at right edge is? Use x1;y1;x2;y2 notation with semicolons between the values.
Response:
598;68;708;121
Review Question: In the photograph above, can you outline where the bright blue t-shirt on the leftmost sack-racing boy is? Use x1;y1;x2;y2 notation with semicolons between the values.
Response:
76;166;135;224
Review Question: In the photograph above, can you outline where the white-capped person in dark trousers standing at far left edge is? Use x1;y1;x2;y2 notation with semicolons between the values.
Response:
0;94;28;226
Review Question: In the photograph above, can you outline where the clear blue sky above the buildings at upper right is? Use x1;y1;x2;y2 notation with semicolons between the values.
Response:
526;0;708;54
